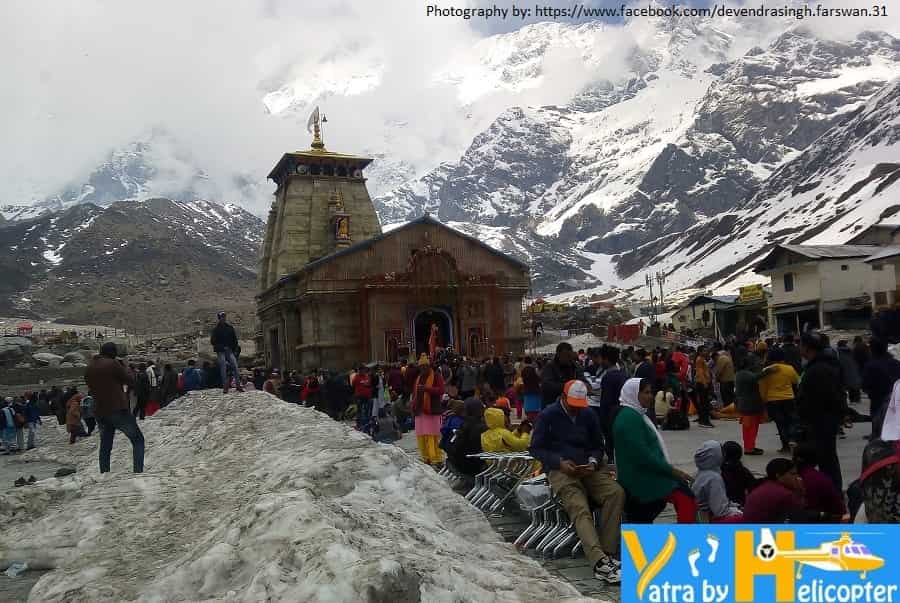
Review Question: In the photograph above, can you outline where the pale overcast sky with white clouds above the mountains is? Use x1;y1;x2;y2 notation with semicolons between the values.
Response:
0;0;900;212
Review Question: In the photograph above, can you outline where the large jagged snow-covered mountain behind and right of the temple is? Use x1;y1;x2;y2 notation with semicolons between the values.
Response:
376;21;900;292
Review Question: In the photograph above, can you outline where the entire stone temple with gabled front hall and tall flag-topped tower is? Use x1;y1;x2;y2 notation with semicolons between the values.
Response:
256;116;530;371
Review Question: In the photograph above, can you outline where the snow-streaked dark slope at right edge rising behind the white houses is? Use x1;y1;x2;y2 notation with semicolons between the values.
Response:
617;80;900;296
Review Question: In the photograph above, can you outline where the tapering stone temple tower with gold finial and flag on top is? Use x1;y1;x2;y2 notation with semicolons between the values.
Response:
259;114;381;293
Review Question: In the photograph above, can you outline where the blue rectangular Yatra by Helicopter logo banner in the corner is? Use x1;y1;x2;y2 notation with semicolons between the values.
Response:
622;524;900;603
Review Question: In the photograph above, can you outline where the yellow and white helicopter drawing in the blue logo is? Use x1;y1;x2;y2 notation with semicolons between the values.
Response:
756;528;884;580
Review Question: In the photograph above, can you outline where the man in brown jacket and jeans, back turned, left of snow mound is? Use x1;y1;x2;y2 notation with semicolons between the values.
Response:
84;342;144;473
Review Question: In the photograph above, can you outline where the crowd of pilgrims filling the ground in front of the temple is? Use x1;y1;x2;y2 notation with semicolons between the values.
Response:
0;333;900;579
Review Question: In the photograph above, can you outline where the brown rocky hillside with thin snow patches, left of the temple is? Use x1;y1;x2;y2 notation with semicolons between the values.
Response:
0;199;264;333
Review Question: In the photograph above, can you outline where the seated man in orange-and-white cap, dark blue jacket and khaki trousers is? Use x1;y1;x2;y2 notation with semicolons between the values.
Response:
530;380;625;584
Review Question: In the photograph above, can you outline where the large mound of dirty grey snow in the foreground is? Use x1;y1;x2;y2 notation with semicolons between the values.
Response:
0;391;592;603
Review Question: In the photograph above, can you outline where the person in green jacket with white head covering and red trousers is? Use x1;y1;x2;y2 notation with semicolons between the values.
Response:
613;379;697;523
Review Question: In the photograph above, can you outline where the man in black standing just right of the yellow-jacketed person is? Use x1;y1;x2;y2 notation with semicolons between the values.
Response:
797;333;844;490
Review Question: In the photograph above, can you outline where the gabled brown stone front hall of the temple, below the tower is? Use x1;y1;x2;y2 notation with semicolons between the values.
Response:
258;224;529;371
